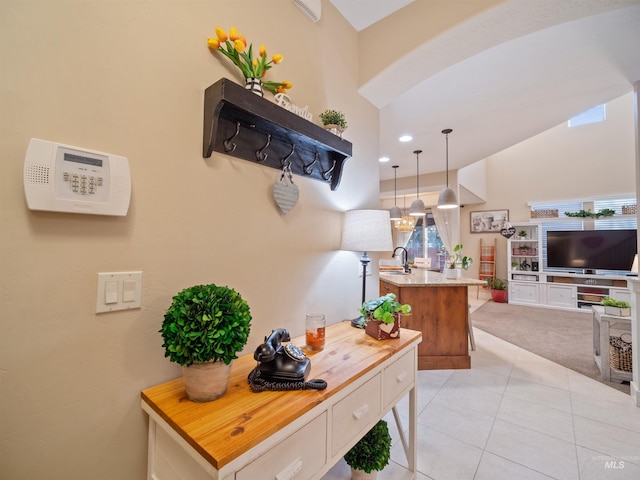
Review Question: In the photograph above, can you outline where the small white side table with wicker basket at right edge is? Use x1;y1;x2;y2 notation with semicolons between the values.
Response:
591;305;632;383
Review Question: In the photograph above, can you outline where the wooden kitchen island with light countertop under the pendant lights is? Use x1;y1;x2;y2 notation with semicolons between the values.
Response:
380;269;486;370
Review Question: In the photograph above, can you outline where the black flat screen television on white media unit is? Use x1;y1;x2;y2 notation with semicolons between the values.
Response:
547;230;638;271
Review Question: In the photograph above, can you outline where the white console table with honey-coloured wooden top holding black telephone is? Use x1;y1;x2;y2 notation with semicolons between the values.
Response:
141;321;422;480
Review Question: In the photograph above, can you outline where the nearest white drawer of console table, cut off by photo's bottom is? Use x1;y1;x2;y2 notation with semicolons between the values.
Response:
236;412;327;480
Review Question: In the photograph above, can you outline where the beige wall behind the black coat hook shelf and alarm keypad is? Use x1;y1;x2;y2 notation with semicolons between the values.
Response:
0;0;379;480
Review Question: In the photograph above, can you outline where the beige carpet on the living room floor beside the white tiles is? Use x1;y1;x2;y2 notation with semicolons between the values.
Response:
471;301;629;393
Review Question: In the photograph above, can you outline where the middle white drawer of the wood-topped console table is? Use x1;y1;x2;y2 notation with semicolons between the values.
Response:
331;374;382;455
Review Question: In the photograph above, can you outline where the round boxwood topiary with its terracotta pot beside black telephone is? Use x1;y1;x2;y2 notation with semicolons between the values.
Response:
160;284;251;402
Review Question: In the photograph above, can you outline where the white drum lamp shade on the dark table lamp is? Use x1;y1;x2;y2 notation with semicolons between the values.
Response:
340;210;393;252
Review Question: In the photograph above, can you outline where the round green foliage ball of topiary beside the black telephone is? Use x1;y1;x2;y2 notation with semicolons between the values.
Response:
160;284;251;366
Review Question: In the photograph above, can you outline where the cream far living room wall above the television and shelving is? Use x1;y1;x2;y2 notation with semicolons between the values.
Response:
460;92;636;278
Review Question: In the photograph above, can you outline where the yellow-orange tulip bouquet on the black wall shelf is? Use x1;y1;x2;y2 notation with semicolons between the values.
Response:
207;27;292;93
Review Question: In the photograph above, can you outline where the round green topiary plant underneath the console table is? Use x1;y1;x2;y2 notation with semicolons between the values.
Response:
344;420;391;480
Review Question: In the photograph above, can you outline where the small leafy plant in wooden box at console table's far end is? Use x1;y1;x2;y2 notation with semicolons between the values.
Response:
358;293;411;340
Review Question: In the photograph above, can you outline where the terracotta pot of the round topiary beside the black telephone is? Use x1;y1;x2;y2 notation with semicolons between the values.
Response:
182;362;231;402
